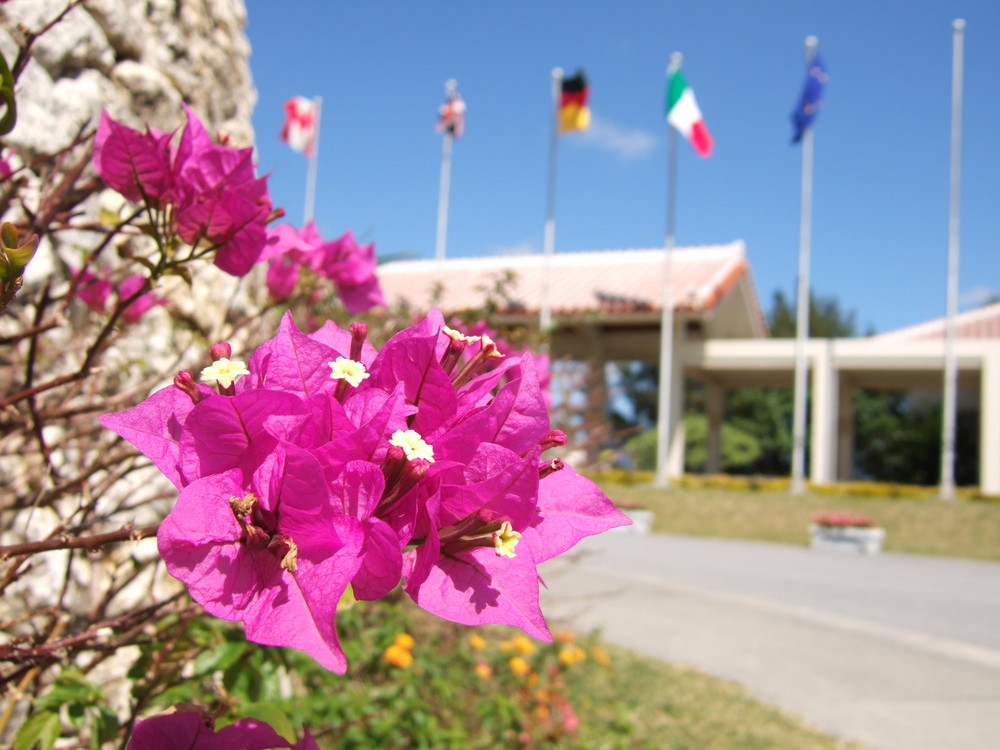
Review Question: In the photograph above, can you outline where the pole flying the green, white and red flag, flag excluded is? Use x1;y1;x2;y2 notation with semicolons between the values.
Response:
653;52;683;489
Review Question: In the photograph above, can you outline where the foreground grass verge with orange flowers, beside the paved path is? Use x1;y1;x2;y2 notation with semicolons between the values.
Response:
315;603;868;750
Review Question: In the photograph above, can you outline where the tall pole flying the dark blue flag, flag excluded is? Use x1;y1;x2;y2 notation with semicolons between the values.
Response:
791;36;818;495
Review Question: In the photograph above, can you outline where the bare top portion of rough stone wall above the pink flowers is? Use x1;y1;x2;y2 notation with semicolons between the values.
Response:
0;0;257;153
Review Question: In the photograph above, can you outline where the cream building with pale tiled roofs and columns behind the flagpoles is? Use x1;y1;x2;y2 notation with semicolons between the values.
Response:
379;242;1000;495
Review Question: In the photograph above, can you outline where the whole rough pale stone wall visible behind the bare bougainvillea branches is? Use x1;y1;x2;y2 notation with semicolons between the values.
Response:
0;5;257;736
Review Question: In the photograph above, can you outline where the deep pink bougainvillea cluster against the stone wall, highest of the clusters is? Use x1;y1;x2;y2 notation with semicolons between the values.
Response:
94;106;271;276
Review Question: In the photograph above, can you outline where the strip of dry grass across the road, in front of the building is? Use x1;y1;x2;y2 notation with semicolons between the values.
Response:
598;478;1000;561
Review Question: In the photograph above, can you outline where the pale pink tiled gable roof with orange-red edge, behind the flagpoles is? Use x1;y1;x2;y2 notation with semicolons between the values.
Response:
378;242;749;316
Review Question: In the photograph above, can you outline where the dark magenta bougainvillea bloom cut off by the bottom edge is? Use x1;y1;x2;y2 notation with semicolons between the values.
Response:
126;711;319;750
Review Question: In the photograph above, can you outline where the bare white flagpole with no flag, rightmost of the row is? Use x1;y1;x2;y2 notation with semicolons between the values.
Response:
940;18;965;500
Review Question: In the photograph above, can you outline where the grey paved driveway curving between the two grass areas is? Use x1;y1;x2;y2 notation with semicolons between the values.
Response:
541;533;1000;750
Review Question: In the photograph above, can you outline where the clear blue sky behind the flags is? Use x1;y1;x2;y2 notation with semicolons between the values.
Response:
247;0;1000;331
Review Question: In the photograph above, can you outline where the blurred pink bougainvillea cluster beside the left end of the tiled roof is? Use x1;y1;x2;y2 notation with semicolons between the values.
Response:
261;221;385;313
